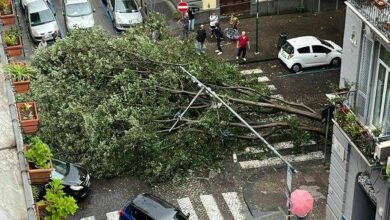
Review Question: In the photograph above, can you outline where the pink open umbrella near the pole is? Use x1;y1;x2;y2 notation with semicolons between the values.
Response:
290;189;314;218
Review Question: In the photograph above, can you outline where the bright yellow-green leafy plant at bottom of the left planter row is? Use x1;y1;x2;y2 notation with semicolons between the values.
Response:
37;179;78;220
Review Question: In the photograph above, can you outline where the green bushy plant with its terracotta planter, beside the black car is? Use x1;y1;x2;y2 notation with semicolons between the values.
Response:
25;137;53;184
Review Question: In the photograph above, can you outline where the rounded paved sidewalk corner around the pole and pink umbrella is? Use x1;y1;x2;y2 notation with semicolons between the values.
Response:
243;163;329;220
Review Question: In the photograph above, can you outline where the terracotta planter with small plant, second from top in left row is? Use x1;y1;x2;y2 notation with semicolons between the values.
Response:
0;27;22;57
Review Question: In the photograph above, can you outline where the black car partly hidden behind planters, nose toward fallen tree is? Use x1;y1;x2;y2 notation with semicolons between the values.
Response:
51;159;91;199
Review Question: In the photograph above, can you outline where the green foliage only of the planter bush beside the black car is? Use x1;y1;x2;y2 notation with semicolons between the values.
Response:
25;137;52;169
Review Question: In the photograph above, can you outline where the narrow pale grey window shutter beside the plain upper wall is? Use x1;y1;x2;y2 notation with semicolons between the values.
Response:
356;37;373;124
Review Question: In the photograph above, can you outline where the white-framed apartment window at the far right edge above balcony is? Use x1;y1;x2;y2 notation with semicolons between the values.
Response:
371;46;390;135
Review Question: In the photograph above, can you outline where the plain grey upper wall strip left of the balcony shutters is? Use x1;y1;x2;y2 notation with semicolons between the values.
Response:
340;7;363;88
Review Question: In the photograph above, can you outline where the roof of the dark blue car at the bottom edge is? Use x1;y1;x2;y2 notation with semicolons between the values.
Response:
131;193;178;220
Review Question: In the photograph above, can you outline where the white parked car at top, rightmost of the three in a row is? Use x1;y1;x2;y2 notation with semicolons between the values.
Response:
106;0;142;30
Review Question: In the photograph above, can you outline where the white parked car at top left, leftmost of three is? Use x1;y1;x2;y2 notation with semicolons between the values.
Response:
25;0;59;42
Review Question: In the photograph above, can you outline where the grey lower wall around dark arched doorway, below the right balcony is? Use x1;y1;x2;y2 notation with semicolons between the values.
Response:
326;124;389;220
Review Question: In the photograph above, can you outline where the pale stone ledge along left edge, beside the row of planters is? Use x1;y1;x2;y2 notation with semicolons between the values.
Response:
0;65;27;220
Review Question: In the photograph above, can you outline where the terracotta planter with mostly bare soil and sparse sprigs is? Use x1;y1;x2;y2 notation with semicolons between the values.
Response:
16;102;39;134
